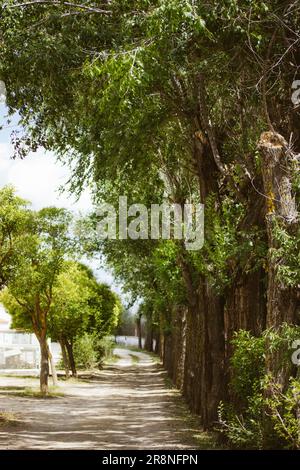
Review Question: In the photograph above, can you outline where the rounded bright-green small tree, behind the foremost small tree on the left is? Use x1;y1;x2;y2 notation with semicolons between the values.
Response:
48;260;121;377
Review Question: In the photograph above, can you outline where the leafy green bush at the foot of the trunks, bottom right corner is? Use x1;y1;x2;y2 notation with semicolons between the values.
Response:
219;325;300;449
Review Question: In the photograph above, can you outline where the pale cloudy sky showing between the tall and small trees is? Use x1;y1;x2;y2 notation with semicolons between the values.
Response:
0;104;121;324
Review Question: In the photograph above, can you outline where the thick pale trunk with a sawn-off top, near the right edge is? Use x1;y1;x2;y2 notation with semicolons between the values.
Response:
258;132;299;387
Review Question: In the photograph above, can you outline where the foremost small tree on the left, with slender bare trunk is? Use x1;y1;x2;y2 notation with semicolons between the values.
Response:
1;208;70;395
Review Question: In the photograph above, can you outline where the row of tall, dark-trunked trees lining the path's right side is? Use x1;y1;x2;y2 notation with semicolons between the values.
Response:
0;0;300;446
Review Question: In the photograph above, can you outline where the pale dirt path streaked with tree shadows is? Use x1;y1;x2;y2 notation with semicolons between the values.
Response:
0;349;209;450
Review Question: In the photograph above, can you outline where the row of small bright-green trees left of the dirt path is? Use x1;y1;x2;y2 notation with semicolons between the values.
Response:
0;187;121;394
